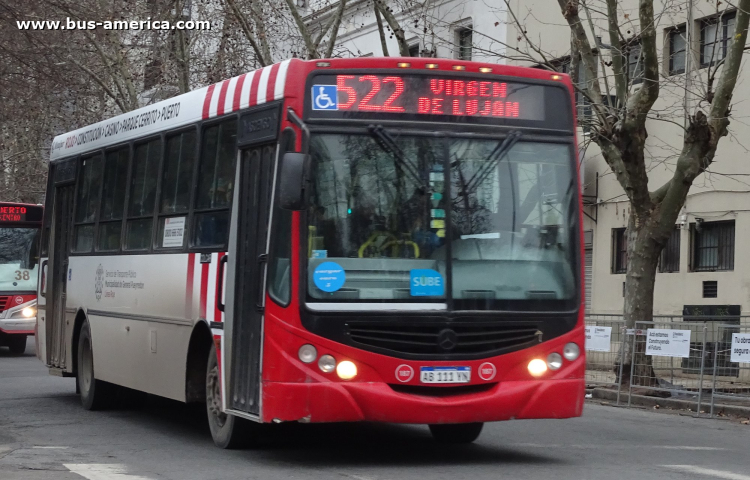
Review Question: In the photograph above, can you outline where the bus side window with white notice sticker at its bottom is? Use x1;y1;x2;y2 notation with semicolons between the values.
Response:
156;129;196;248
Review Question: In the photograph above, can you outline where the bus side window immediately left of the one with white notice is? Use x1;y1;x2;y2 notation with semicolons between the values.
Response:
125;138;162;250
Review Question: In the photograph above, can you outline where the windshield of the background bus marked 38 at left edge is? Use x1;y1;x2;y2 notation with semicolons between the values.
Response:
0;227;39;294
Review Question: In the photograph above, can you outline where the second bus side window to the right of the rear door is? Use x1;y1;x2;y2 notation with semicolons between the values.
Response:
96;147;130;251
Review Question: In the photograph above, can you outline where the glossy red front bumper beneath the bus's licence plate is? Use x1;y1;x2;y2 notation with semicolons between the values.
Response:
263;379;585;424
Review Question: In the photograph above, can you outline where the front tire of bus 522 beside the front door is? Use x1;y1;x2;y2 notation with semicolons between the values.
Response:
206;346;251;449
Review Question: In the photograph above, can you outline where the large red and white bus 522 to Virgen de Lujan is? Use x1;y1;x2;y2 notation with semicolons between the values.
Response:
39;58;584;447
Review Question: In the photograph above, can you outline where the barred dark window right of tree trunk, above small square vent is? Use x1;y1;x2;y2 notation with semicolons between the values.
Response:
692;220;734;272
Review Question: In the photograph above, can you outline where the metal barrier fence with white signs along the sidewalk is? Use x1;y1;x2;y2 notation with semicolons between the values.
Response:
586;314;750;415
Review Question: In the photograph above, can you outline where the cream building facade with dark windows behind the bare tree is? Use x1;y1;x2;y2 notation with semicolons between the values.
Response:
304;0;750;316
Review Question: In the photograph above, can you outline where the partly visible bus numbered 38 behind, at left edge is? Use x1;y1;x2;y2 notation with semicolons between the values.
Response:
0;202;43;355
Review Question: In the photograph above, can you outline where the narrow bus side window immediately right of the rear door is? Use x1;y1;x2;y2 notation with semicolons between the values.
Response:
73;154;103;253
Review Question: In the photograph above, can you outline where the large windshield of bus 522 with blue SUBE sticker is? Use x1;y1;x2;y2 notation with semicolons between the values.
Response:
306;129;578;310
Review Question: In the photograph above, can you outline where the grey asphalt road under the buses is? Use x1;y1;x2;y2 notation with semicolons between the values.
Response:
0;340;750;480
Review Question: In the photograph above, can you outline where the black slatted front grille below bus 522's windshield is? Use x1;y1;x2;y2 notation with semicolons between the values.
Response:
347;322;541;356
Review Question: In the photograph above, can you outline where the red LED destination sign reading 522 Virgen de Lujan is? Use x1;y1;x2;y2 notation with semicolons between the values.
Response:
310;74;564;121
